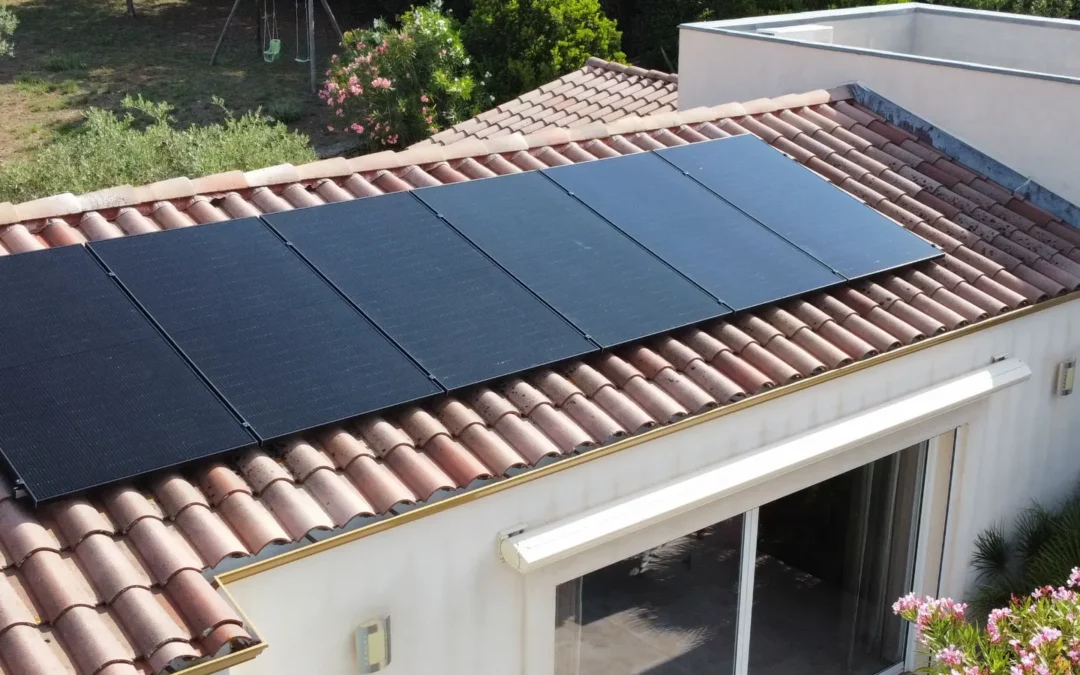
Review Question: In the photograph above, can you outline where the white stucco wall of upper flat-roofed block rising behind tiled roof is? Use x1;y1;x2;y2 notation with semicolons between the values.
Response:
678;26;1080;203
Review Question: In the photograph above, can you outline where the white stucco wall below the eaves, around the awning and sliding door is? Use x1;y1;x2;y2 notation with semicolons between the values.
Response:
229;300;1080;675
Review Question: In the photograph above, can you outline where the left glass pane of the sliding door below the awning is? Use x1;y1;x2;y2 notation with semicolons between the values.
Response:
555;515;743;675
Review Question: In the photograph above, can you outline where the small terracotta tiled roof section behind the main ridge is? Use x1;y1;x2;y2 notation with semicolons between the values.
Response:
417;56;678;146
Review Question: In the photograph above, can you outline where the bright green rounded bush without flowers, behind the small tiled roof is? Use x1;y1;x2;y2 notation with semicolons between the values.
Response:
464;0;625;102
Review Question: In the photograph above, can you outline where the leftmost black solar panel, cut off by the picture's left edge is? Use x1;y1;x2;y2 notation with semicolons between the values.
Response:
0;246;255;501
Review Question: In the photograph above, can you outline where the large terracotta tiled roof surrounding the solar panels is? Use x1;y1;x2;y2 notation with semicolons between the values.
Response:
0;85;1080;675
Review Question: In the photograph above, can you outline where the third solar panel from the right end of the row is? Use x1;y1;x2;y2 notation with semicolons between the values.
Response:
415;172;731;347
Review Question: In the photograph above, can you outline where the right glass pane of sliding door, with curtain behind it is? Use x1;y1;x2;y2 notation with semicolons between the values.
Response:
748;444;927;675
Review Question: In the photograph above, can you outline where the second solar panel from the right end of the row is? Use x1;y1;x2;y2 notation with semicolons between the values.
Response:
544;152;845;311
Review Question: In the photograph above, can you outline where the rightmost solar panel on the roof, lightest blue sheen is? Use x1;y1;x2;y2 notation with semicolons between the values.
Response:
656;134;942;279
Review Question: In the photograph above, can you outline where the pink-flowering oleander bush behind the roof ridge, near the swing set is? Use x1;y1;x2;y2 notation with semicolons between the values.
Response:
319;2;480;148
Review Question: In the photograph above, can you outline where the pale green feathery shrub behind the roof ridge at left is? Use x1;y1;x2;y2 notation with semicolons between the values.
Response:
0;96;315;202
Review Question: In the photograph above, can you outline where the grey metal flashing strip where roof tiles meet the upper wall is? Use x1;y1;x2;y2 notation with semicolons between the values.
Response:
848;82;1080;229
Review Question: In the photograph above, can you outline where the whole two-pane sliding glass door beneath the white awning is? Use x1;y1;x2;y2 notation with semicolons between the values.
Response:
555;444;927;675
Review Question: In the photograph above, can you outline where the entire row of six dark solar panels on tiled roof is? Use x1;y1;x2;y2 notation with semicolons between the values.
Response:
0;137;941;501
